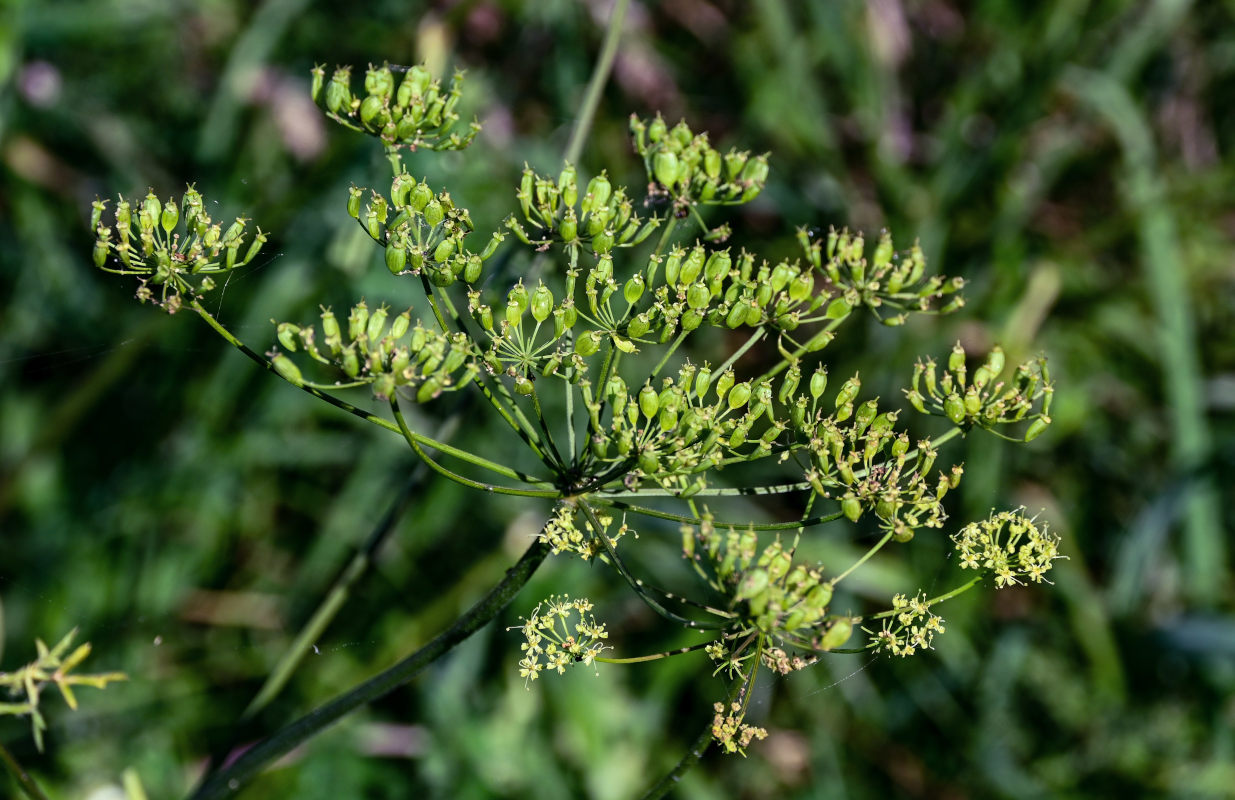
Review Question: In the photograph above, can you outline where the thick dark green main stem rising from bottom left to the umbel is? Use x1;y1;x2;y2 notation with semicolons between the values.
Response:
190;540;548;800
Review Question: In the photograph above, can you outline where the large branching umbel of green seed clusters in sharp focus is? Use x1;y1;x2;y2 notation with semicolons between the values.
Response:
84;39;1057;798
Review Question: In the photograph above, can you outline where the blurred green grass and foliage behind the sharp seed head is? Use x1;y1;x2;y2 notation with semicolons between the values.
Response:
0;0;1235;799
